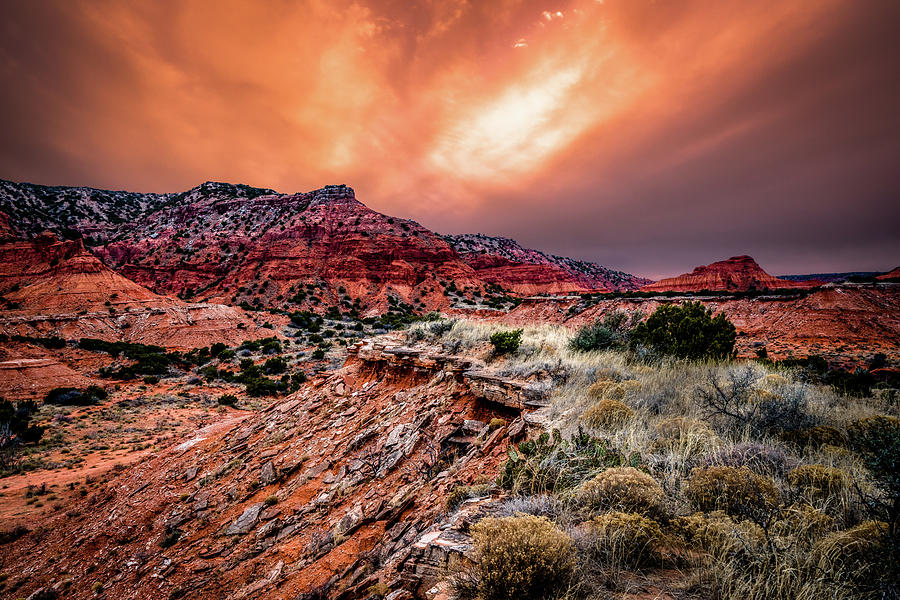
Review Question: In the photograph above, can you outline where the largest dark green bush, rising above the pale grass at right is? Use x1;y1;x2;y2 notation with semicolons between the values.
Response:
630;302;737;360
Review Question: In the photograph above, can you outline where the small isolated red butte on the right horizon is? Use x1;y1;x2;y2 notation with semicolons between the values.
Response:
641;256;821;292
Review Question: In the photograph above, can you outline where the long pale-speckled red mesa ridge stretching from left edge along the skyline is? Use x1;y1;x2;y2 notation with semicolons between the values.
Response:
0;182;647;312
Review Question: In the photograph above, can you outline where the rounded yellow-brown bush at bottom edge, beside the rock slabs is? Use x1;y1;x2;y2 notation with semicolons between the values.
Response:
464;515;575;600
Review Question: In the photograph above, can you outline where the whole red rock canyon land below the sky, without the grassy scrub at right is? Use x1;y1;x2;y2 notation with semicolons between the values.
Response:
0;182;900;600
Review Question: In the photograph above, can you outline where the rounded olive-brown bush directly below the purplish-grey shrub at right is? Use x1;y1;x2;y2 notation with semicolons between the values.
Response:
685;467;779;518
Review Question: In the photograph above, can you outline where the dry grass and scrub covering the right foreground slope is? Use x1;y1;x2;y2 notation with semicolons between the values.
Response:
412;322;900;600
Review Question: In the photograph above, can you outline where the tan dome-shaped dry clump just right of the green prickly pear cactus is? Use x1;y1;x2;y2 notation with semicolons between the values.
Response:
576;467;665;516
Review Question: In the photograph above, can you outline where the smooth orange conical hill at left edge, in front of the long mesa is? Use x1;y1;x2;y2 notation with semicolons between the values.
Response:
0;232;263;347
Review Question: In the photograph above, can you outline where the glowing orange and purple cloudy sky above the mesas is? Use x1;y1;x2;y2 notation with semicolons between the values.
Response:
0;0;900;278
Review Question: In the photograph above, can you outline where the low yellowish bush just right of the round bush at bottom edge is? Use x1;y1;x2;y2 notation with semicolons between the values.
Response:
590;512;663;567
